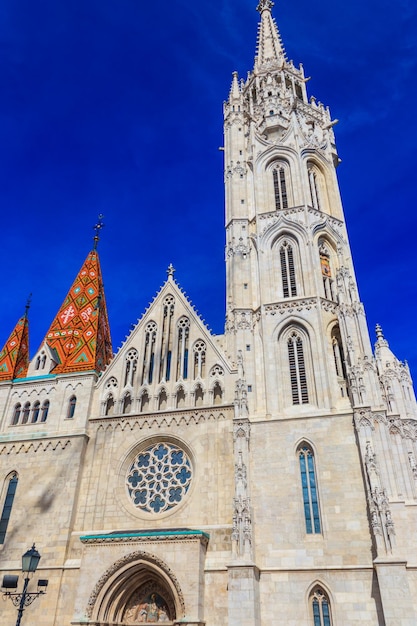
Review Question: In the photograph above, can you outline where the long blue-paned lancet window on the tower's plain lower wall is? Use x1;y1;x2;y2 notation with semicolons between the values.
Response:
298;443;321;535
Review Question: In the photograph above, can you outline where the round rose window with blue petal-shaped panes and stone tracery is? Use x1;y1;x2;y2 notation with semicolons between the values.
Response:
126;442;192;513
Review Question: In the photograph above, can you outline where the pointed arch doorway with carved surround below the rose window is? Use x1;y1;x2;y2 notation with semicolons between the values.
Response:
87;551;185;626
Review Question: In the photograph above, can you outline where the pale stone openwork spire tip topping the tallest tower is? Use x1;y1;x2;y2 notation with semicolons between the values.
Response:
255;0;286;71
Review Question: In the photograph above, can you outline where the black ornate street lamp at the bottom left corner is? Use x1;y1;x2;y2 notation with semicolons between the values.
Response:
2;544;48;626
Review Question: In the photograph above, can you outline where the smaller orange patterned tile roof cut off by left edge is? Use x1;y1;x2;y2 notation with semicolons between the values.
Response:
0;314;29;380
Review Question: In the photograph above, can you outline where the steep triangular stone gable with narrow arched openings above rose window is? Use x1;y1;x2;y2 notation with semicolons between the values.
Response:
98;274;234;414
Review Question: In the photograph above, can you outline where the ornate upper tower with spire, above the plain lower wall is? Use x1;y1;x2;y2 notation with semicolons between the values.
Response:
224;0;382;418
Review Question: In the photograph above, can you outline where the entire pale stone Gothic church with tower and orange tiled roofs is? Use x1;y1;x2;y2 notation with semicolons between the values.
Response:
0;0;417;626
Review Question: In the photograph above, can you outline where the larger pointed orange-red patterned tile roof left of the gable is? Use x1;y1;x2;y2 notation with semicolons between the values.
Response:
45;250;113;374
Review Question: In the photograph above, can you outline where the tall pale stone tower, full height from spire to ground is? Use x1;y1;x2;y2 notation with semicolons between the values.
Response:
224;0;417;626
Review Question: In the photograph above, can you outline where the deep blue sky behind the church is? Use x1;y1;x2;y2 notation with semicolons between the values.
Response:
0;0;417;377
